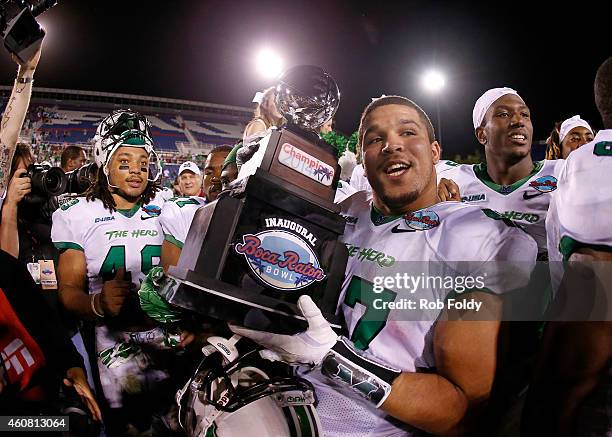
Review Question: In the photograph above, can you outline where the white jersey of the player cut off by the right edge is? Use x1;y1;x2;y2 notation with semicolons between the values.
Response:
546;129;612;290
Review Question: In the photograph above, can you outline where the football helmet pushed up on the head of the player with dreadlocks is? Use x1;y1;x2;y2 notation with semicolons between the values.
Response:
93;109;162;182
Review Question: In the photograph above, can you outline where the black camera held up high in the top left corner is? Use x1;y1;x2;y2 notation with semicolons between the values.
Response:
0;0;57;62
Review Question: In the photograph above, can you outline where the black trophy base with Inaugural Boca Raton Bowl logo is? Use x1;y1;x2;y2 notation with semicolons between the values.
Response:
165;162;348;333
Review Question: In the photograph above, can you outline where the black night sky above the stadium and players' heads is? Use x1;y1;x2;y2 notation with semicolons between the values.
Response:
0;0;612;157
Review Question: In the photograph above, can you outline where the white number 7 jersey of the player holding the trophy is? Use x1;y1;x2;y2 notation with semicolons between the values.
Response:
304;196;537;436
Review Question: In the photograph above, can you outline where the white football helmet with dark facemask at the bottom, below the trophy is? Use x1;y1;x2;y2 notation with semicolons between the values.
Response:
176;337;323;437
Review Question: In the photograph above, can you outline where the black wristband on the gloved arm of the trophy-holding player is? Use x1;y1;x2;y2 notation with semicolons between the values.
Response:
321;337;402;408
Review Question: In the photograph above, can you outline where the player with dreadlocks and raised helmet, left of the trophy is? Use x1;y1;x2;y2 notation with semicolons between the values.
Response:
51;110;187;435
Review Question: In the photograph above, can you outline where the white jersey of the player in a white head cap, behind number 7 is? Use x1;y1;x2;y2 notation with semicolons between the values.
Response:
436;159;564;252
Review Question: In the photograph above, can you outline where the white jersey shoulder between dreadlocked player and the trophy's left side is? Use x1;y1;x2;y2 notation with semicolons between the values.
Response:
159;196;206;249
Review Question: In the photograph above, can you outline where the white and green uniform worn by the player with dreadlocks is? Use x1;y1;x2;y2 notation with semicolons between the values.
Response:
51;195;167;408
